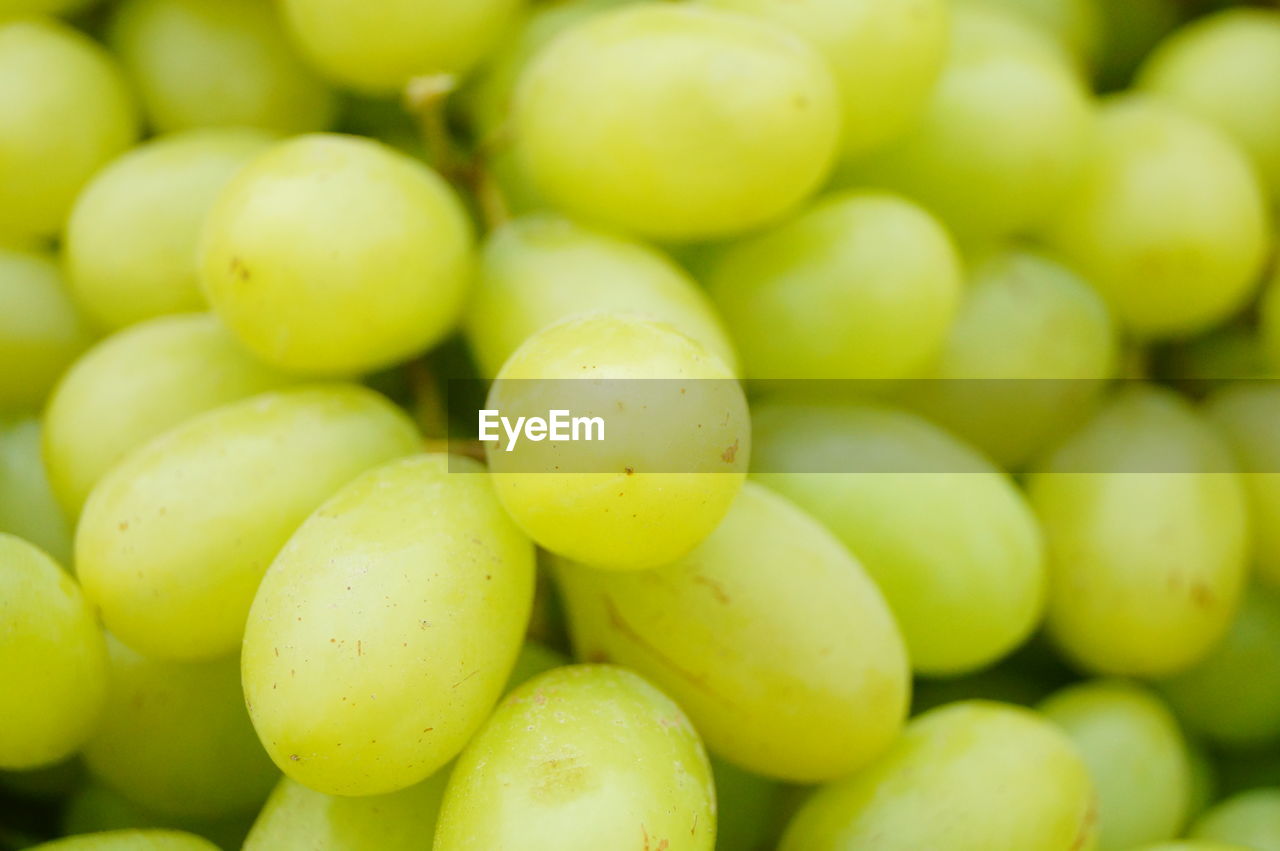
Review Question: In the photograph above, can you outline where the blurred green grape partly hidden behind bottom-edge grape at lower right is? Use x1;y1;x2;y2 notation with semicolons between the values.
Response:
1039;680;1192;851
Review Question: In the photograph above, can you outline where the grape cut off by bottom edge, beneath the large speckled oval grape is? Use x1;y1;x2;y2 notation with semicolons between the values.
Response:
244;770;449;851
